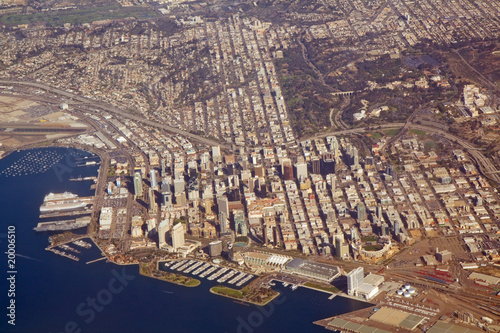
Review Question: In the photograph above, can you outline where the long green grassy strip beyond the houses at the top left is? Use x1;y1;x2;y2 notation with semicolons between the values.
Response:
0;4;159;26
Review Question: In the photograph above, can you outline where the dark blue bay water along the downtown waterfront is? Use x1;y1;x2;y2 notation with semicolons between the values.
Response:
0;148;367;333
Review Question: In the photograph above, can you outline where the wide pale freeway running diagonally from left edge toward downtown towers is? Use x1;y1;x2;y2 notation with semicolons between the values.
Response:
0;80;229;148
